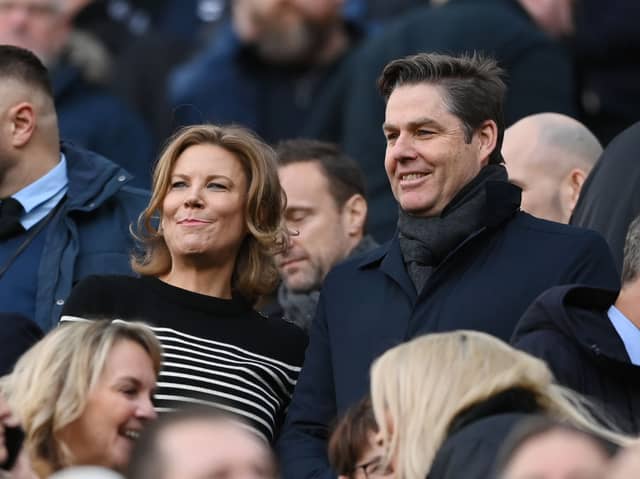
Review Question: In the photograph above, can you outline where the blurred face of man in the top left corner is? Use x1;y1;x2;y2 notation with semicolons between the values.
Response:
0;0;69;66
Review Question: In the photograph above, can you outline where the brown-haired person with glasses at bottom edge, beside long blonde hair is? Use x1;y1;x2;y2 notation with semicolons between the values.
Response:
329;396;393;479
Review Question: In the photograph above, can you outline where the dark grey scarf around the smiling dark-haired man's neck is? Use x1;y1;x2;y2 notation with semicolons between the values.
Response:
398;165;508;293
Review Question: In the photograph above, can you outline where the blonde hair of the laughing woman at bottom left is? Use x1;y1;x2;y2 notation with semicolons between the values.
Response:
0;320;162;477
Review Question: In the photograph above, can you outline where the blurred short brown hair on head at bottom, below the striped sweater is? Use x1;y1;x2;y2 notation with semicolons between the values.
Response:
126;405;275;479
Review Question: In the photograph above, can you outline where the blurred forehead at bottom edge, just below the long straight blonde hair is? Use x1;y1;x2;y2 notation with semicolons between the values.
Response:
502;430;609;479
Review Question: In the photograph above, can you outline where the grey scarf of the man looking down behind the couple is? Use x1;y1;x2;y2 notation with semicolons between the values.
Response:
278;235;378;332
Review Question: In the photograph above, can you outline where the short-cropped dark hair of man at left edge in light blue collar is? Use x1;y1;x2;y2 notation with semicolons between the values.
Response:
0;45;53;99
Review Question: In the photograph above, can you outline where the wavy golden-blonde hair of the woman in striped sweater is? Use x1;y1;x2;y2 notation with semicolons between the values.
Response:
131;125;287;301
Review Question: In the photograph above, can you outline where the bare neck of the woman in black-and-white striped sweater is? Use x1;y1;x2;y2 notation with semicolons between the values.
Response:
159;263;233;299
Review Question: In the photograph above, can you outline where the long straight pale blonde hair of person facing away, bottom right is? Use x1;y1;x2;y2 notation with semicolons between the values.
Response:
371;331;629;479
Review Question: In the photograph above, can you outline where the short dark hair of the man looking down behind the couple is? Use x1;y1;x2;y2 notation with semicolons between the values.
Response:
276;139;365;208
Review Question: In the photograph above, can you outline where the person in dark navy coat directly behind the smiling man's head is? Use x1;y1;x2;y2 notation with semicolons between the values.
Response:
302;0;577;241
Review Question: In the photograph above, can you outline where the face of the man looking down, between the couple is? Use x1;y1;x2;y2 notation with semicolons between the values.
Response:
277;162;353;292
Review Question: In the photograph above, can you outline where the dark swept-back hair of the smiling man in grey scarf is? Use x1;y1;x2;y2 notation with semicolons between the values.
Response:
378;53;507;164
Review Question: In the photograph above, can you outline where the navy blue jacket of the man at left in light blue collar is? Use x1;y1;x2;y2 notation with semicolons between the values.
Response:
33;143;149;332
